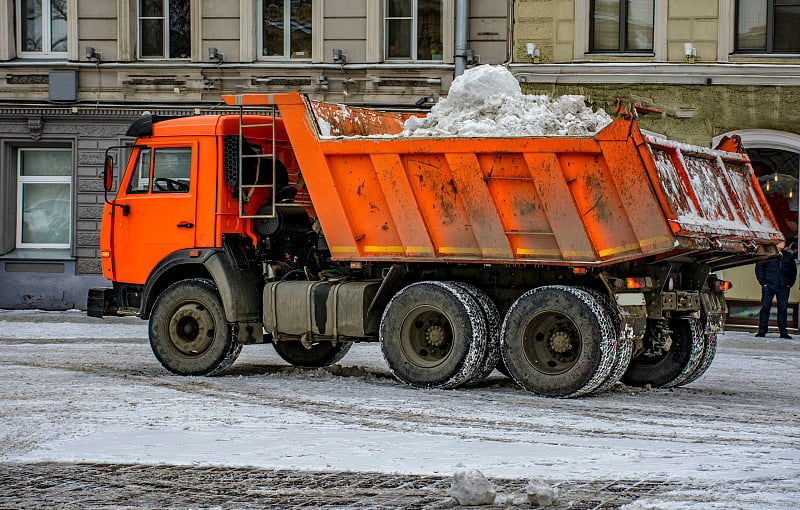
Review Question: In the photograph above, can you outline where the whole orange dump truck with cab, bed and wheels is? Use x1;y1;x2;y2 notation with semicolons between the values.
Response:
89;93;782;397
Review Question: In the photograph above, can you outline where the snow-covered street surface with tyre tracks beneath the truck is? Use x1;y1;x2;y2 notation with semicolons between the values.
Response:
0;311;800;509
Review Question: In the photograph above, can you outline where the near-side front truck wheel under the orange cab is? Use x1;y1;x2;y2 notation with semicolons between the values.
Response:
148;279;242;375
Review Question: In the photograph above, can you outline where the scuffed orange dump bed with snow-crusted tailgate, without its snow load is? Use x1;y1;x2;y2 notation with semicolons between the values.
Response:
225;93;782;269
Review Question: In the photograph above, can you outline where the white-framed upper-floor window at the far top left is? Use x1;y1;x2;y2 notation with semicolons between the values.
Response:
17;0;67;57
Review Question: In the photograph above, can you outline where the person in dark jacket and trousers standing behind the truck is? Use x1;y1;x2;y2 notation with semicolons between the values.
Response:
756;243;797;338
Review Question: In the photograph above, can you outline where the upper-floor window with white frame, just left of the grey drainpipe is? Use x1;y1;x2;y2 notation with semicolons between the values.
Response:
384;0;442;60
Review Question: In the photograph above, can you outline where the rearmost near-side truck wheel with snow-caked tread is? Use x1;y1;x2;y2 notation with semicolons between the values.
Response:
501;285;616;397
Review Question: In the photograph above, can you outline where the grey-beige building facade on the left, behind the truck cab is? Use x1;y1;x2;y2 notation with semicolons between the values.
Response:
0;0;511;309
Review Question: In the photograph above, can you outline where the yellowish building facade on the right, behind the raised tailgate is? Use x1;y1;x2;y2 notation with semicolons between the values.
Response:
510;0;800;327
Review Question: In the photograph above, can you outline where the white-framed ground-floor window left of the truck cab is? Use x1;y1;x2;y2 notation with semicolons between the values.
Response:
17;149;72;248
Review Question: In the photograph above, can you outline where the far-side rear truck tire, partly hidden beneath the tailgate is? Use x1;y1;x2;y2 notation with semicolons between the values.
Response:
622;318;704;388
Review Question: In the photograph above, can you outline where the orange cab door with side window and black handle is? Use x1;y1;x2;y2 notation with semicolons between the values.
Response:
111;142;198;284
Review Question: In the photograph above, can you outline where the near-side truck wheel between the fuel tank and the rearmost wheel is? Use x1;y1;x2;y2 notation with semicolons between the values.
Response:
379;281;486;388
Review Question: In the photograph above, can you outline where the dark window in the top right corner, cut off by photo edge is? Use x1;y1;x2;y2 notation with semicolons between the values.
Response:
735;0;800;53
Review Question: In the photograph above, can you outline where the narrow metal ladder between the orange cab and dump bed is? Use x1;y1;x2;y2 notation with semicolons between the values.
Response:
237;105;277;218
